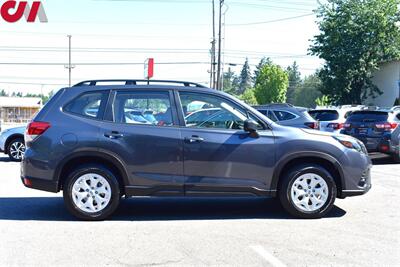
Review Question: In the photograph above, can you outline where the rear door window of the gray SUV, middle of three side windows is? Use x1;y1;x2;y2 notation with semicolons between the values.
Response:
113;92;173;126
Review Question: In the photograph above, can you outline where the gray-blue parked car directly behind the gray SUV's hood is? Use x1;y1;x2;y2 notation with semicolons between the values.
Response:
254;104;319;129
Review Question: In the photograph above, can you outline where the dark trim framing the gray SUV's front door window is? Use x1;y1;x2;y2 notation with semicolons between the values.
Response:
174;89;272;132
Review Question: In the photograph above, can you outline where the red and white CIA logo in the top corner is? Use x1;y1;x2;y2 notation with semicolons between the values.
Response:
0;0;48;23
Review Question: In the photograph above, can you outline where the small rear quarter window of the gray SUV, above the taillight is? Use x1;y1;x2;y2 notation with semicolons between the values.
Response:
64;91;108;119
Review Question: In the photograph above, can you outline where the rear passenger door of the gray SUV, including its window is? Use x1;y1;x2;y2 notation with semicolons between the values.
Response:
100;90;183;196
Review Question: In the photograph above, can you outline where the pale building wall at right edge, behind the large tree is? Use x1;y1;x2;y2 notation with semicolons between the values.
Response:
364;60;400;107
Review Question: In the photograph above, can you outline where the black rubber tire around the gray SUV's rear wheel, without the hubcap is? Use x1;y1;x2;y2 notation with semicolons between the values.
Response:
63;164;121;221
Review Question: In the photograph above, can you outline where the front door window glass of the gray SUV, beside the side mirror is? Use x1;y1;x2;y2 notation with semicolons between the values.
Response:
179;92;260;130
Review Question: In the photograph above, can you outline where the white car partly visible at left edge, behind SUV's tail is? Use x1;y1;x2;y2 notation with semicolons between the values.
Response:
0;126;26;161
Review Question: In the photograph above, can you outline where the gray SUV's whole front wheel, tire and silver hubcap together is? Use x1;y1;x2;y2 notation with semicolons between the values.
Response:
279;165;337;219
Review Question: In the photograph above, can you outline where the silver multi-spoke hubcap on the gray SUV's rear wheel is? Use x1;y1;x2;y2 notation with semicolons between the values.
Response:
72;173;111;213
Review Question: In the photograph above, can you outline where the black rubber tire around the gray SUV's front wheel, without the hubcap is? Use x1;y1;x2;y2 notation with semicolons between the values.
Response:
278;165;337;219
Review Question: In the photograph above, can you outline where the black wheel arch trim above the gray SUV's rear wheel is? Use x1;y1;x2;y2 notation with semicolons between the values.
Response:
54;150;129;190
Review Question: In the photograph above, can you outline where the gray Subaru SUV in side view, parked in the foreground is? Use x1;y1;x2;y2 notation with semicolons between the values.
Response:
21;80;371;220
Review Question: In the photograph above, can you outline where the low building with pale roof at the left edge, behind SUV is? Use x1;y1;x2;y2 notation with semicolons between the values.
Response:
0;97;43;130
